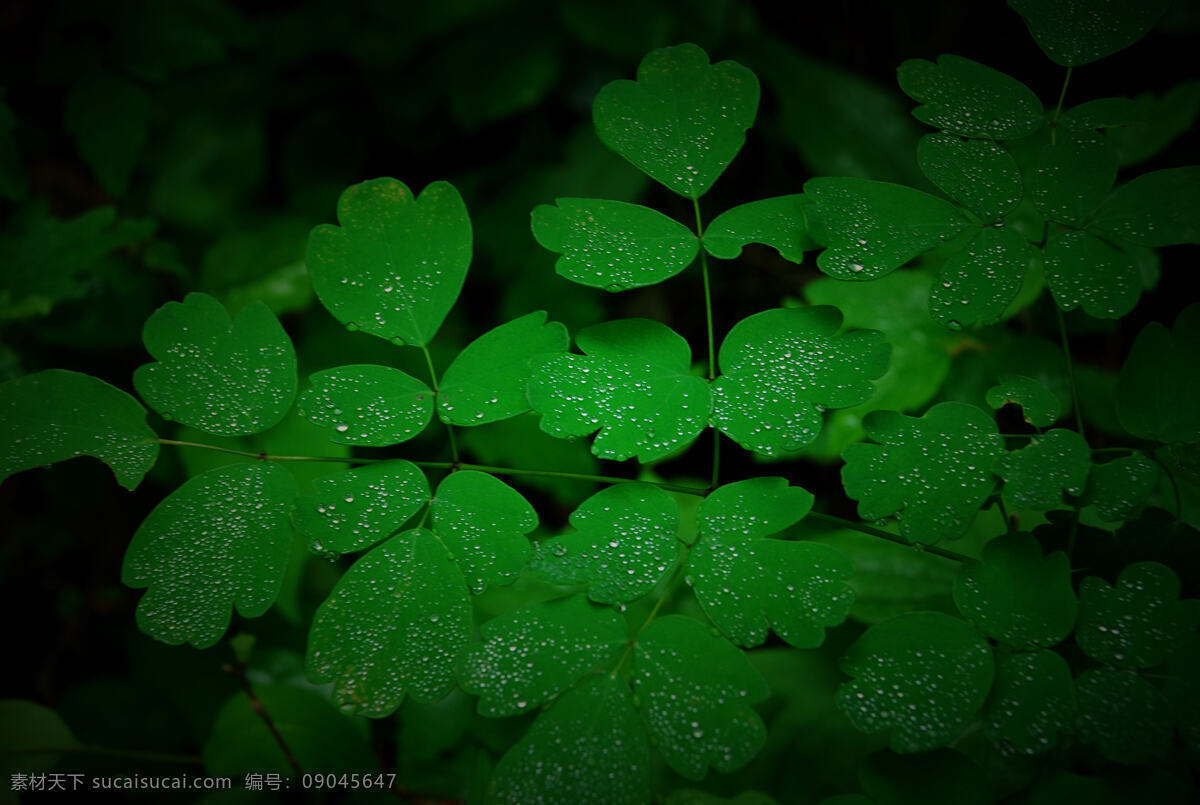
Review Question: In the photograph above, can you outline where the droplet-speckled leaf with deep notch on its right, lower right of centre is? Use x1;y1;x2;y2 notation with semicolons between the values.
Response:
688;477;854;648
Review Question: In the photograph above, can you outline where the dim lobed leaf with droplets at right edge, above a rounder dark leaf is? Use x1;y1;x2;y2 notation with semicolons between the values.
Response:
1075;561;1200;668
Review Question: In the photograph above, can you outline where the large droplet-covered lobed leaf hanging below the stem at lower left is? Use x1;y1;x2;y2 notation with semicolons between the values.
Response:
121;462;296;649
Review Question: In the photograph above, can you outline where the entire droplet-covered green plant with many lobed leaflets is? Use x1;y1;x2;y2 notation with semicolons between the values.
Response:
0;0;1200;803
